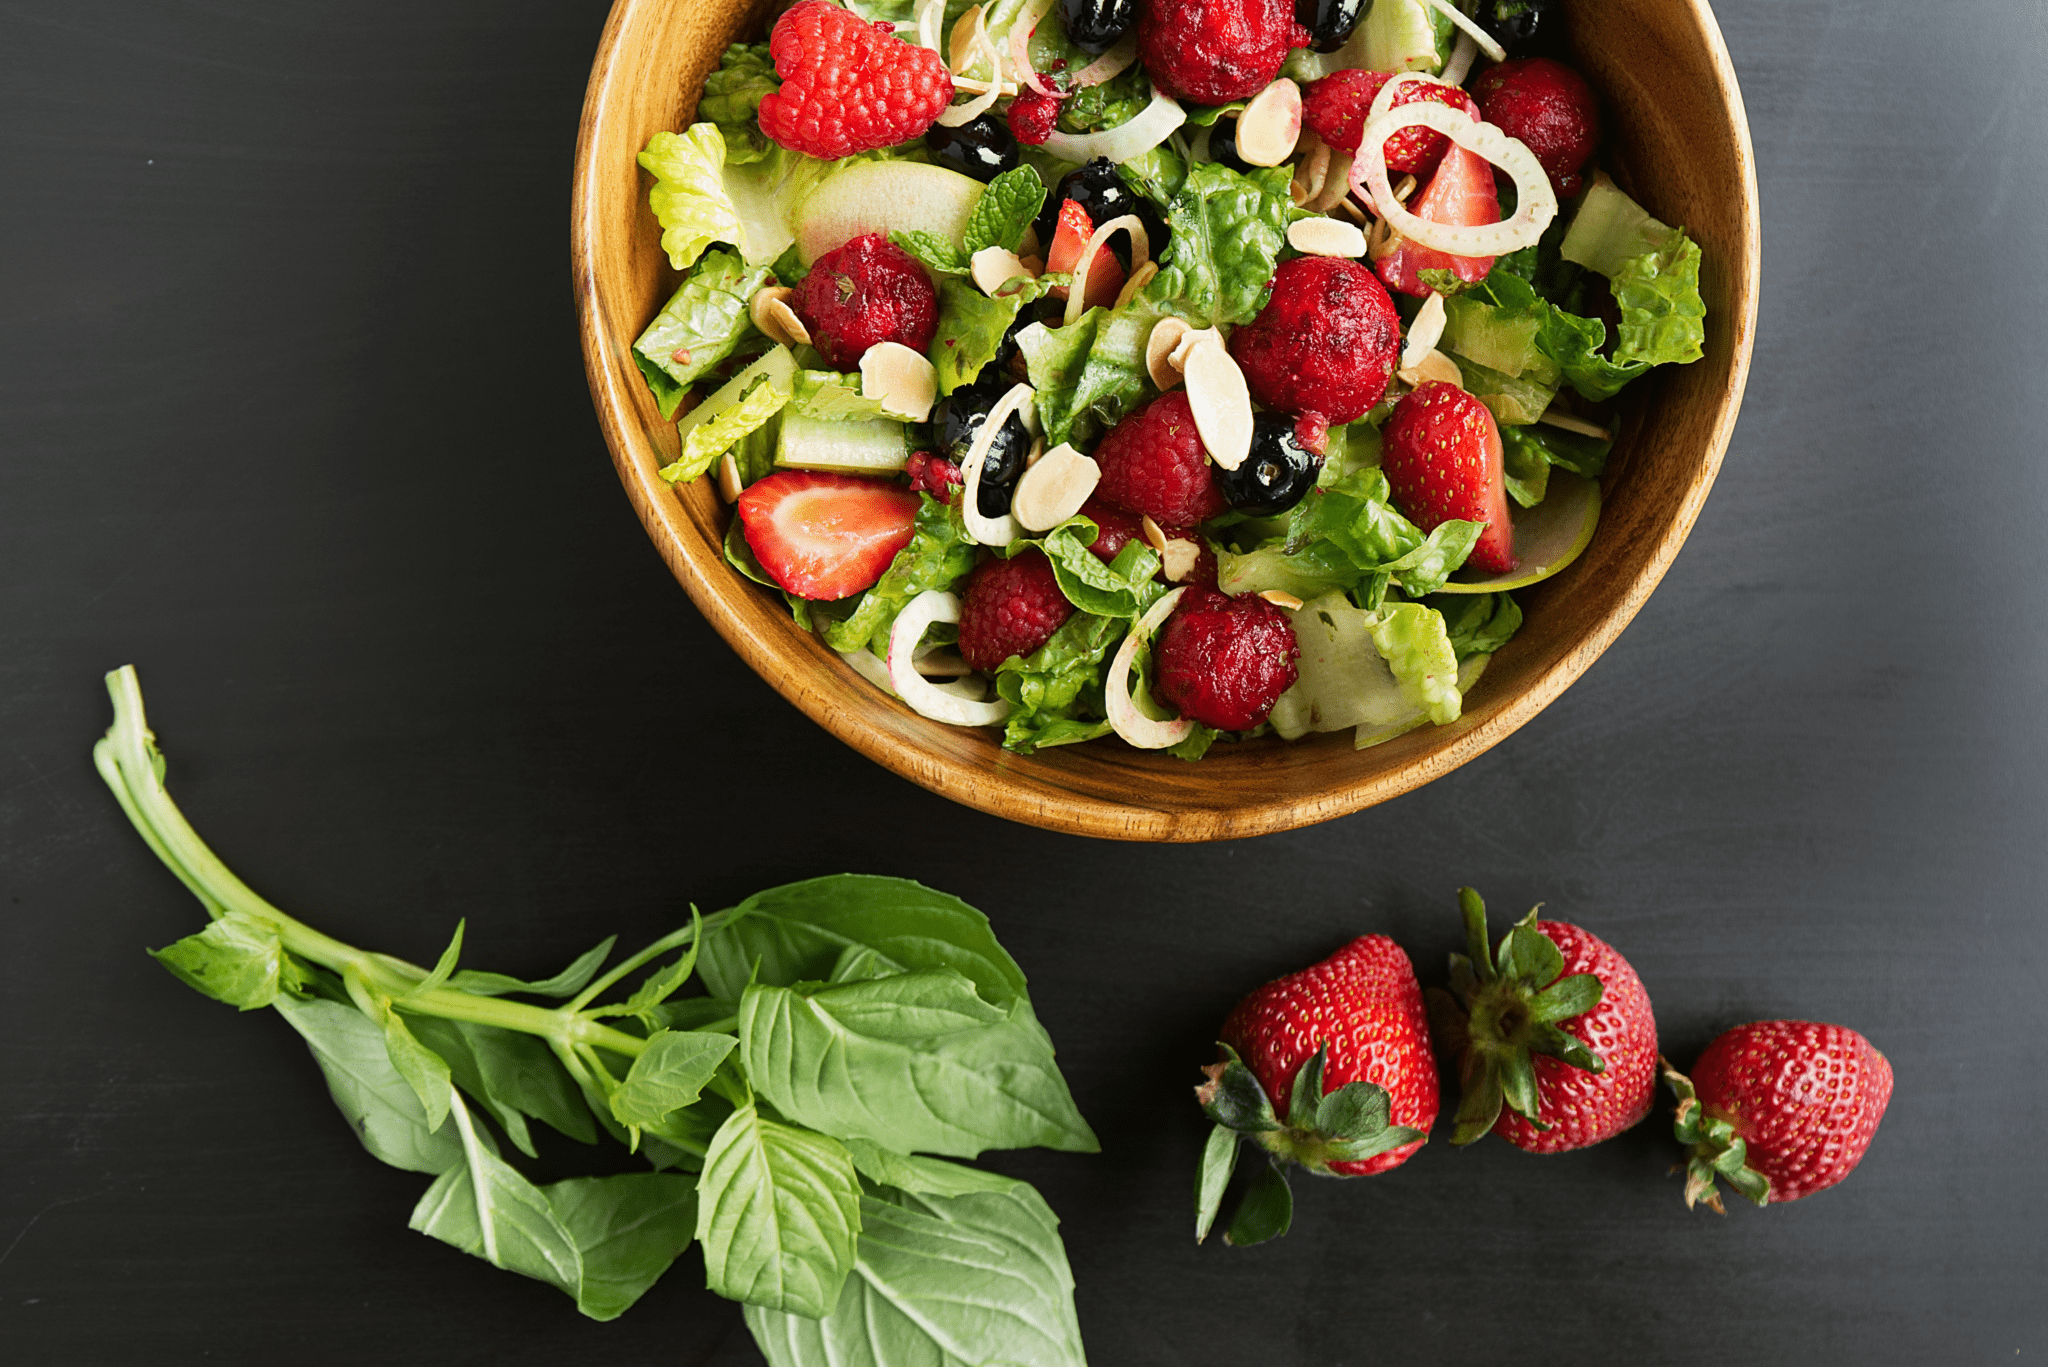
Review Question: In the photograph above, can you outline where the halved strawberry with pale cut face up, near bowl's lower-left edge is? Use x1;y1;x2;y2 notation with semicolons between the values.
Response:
737;469;918;598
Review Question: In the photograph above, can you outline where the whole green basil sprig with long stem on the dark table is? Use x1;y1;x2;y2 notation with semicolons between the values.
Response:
94;668;1098;1367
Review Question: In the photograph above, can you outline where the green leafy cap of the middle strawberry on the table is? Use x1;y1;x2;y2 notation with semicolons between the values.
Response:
1427;887;1608;1146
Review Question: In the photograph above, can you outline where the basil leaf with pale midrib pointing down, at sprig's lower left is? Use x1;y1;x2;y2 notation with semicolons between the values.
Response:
410;1096;584;1295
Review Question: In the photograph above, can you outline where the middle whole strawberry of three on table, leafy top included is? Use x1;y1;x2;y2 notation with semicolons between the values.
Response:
1430;887;1657;1154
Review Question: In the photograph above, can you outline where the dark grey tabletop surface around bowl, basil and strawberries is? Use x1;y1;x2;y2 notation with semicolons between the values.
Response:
0;0;2048;1367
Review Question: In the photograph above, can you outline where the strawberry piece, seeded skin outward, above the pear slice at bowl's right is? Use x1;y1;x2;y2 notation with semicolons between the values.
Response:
1380;381;1516;574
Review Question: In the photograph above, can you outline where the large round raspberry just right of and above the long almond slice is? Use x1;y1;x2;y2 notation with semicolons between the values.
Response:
1231;256;1401;422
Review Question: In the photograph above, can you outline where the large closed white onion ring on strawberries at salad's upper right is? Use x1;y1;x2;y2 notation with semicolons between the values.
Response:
1352;102;1556;256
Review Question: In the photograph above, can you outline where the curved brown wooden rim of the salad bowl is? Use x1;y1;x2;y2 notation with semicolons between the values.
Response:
569;0;1761;840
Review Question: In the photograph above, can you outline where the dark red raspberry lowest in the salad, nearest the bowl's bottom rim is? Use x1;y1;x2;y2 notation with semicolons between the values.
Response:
1155;588;1300;732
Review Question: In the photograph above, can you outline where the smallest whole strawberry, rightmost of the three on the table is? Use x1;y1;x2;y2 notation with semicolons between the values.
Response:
1663;1021;1892;1211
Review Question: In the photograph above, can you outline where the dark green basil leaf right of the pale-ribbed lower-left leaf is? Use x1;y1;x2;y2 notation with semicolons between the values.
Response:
541;1172;696;1320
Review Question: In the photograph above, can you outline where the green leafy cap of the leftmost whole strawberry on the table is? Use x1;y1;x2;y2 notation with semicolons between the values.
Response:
1194;1041;1423;1244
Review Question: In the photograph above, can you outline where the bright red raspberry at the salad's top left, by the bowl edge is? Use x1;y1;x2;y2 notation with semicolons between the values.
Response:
760;0;952;162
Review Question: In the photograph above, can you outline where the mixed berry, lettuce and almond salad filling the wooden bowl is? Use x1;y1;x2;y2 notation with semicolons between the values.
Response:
606;0;1706;758
